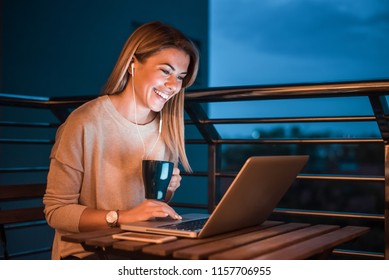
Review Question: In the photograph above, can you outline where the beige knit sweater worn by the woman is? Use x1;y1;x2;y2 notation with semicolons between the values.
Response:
43;96;171;259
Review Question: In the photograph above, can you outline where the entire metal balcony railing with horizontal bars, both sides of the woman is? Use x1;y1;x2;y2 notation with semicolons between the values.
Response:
0;81;389;259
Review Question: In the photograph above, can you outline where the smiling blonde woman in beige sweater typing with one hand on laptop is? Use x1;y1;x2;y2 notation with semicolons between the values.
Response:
43;22;199;259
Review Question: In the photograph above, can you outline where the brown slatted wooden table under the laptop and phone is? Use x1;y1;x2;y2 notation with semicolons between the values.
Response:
62;221;369;260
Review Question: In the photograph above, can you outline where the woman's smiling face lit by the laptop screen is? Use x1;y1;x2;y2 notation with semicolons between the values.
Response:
130;48;190;112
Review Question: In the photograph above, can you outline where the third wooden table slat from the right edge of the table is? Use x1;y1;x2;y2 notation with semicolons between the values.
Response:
173;223;309;260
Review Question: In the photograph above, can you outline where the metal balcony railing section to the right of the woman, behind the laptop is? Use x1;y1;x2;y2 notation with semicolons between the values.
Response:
185;78;389;259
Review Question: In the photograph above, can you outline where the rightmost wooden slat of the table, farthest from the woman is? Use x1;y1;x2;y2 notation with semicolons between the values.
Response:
254;226;369;260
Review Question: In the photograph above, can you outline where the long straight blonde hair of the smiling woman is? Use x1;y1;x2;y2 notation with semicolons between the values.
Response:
103;21;199;172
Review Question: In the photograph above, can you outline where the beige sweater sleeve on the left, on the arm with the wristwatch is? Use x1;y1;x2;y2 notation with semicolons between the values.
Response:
43;117;86;232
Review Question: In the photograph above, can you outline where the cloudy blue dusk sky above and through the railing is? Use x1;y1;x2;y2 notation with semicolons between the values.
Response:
209;0;389;138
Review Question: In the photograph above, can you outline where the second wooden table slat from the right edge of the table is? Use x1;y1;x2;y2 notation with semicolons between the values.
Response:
209;225;339;260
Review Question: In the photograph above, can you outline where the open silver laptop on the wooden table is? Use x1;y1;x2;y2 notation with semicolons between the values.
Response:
120;156;309;238
